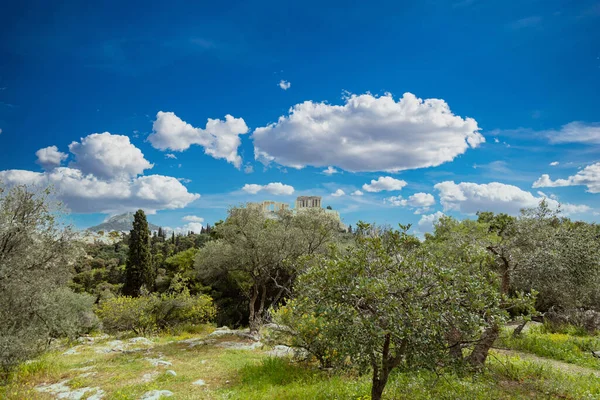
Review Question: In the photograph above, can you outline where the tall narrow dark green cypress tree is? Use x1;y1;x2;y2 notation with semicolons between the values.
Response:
123;210;154;296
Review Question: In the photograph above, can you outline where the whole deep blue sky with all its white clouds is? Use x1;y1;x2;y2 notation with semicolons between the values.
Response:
0;0;600;232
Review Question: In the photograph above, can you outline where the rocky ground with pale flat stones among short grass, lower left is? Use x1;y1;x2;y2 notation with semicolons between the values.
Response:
24;327;293;400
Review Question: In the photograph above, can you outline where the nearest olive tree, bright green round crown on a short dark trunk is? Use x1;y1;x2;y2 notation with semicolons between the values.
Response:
275;223;504;399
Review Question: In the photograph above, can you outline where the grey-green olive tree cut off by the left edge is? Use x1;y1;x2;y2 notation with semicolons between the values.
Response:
0;184;94;378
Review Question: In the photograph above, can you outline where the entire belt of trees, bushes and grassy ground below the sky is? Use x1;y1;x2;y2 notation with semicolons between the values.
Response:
0;186;600;400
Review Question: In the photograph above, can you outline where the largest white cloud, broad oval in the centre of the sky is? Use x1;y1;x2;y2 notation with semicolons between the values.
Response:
252;93;485;172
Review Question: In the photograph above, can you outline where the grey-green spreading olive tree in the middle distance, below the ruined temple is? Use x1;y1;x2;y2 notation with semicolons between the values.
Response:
195;205;339;333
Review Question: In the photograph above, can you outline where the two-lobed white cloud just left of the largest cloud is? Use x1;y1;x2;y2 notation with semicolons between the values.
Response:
148;111;248;168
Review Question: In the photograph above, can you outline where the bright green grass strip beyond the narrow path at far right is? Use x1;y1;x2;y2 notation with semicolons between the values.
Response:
496;327;600;370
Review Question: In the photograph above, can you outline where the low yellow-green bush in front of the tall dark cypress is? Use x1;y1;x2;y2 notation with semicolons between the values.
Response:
96;292;216;335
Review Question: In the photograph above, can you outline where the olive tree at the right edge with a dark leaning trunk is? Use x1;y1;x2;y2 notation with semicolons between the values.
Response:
427;201;600;366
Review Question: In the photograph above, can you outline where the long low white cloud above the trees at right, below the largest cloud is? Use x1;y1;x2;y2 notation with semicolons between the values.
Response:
434;181;590;215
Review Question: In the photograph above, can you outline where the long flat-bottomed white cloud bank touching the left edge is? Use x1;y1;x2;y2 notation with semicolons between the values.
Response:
0;167;200;213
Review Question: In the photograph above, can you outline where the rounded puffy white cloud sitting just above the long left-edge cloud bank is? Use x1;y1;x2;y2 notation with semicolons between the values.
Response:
69;132;153;179
